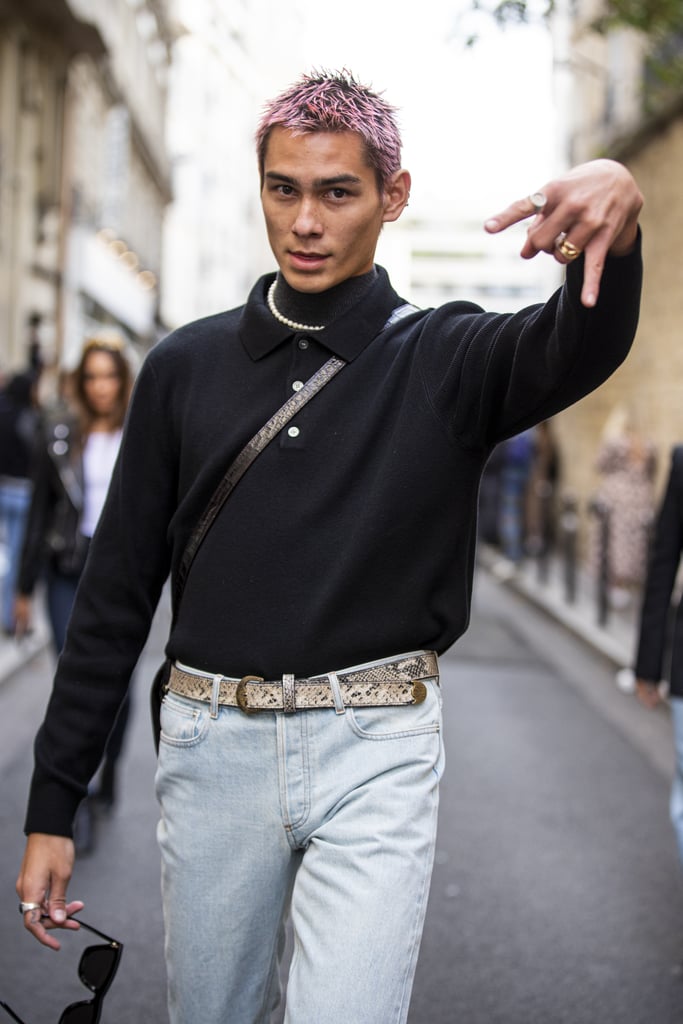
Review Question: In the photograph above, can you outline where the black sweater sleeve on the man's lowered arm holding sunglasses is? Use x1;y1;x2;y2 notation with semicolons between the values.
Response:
25;357;177;836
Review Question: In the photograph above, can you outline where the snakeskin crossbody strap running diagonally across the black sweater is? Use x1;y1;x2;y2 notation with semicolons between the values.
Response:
173;355;346;616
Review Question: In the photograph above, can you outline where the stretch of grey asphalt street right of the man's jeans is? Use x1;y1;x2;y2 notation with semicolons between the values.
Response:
411;580;683;1024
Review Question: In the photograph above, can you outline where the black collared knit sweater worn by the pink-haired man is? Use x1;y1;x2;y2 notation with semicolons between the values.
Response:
26;245;641;835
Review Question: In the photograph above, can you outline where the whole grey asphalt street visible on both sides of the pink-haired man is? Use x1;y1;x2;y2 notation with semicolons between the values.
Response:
0;574;683;1024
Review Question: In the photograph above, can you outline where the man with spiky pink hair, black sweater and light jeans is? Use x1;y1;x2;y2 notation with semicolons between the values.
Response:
17;72;642;1024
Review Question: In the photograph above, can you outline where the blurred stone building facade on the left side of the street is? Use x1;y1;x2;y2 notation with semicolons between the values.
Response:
0;0;173;372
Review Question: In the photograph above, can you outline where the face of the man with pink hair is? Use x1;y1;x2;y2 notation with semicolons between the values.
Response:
261;128;404;293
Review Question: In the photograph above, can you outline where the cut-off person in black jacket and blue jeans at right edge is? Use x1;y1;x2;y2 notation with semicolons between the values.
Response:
635;444;683;866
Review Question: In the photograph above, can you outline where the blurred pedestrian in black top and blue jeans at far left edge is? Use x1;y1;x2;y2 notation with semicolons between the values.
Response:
0;373;40;636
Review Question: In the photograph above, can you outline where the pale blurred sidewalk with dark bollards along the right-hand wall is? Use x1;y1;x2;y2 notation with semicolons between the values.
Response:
477;543;638;670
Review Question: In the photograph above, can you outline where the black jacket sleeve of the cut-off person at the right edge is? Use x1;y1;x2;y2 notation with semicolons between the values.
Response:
635;446;683;682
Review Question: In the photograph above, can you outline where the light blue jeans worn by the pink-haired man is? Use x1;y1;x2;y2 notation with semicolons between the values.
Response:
157;663;443;1024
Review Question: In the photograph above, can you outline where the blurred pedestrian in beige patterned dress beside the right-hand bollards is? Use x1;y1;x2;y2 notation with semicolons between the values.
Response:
593;404;656;608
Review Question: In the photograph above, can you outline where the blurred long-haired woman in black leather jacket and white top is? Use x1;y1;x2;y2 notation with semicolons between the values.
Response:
14;334;133;852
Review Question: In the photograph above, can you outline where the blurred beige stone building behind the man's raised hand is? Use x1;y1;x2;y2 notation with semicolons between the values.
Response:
555;0;683;550
